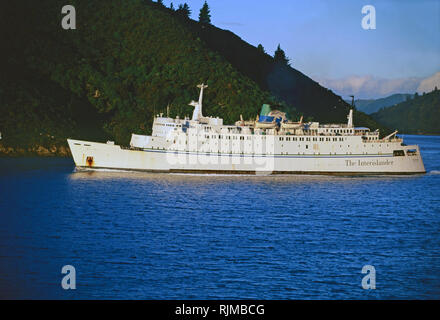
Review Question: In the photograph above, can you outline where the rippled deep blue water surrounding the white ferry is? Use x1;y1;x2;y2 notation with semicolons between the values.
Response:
0;136;440;299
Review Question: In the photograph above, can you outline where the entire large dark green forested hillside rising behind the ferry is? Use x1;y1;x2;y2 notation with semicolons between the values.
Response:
0;0;384;154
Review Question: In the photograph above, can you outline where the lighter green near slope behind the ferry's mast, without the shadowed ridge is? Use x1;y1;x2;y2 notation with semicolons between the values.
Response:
0;0;271;151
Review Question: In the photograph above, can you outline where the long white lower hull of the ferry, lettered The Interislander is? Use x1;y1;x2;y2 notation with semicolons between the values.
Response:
68;139;425;175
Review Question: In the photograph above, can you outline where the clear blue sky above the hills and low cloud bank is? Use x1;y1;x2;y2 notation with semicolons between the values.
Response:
164;0;440;79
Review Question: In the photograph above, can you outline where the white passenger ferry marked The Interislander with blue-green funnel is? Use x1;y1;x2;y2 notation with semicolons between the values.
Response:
67;84;425;175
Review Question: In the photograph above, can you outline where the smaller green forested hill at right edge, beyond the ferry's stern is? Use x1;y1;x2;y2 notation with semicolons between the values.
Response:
371;90;440;134
